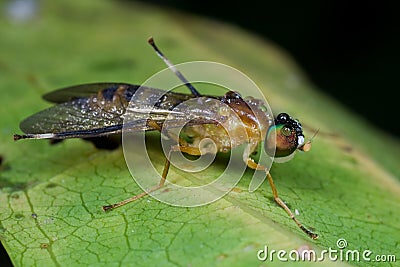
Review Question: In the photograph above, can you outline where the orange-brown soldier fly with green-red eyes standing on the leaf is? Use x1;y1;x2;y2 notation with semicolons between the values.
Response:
14;38;318;239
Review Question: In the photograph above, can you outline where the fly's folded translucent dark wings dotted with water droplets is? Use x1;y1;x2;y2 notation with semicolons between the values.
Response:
20;83;222;139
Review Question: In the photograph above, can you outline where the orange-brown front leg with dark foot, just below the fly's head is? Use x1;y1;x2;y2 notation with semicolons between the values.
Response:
245;158;318;239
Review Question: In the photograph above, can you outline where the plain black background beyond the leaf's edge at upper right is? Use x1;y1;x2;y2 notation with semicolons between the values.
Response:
136;0;400;137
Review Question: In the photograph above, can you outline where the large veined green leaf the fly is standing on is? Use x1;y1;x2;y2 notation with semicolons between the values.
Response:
0;0;400;266
